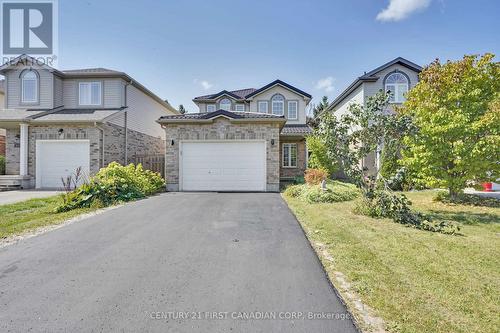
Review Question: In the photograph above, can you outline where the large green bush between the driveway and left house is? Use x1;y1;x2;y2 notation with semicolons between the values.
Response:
56;162;165;212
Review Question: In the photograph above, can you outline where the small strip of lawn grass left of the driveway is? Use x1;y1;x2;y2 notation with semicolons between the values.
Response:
0;195;96;238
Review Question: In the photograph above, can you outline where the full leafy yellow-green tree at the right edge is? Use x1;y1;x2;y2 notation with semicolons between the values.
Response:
400;54;500;200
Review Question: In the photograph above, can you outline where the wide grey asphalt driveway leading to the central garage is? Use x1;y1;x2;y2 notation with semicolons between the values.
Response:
0;193;356;333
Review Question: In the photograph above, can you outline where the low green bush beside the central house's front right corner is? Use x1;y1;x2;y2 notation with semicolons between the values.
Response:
284;181;359;204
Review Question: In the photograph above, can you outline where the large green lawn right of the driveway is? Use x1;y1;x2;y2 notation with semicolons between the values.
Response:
284;191;500;333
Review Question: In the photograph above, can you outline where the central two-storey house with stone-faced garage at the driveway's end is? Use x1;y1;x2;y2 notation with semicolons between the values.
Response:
158;80;311;192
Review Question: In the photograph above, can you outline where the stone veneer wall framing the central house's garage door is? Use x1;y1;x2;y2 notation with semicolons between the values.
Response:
165;118;280;192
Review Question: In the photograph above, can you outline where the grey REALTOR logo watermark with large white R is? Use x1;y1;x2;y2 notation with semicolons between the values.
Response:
0;0;58;66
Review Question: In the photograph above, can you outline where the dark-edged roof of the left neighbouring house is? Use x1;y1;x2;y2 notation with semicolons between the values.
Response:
0;54;179;113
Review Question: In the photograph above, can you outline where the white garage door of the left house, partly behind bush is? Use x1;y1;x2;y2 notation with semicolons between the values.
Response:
36;140;90;188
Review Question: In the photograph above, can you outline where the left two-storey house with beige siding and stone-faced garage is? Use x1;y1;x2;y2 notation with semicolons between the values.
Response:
0;55;177;188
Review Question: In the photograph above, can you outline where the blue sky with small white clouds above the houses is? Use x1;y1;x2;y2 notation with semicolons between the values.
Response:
59;0;500;111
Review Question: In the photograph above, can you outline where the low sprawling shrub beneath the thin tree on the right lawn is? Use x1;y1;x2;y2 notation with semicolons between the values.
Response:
355;190;460;234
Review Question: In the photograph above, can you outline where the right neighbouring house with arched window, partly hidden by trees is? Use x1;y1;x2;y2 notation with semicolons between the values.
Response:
328;57;422;171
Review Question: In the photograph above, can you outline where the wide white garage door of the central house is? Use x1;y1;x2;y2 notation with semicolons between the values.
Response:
179;141;266;191
